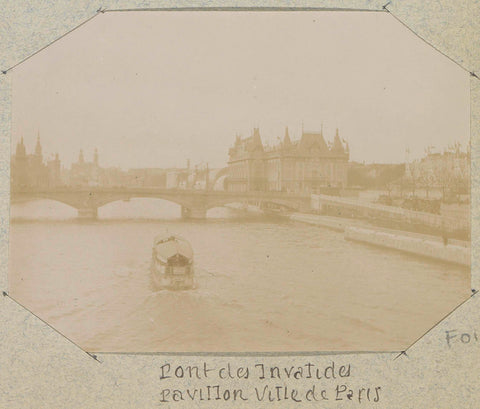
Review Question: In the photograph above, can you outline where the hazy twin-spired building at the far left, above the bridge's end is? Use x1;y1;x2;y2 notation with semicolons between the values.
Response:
10;136;58;189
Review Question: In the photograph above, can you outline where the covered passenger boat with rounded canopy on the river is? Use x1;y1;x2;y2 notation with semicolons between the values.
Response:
150;235;194;290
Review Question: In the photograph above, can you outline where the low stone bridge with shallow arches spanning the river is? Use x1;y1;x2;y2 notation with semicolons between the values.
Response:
11;187;310;219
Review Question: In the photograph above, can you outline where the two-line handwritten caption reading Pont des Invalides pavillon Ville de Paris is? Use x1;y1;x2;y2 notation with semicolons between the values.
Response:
159;361;382;404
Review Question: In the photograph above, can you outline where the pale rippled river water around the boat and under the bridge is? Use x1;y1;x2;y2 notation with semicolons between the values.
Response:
9;199;470;352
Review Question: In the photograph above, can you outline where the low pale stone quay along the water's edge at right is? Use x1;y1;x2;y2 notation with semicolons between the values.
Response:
290;213;471;267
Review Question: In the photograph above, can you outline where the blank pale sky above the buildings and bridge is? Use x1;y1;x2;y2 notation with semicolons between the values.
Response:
11;11;470;168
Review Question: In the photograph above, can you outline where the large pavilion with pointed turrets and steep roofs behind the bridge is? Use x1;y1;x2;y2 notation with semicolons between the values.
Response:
227;128;349;194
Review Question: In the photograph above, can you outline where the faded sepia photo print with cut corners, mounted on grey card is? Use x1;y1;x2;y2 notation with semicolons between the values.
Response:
8;10;471;353
